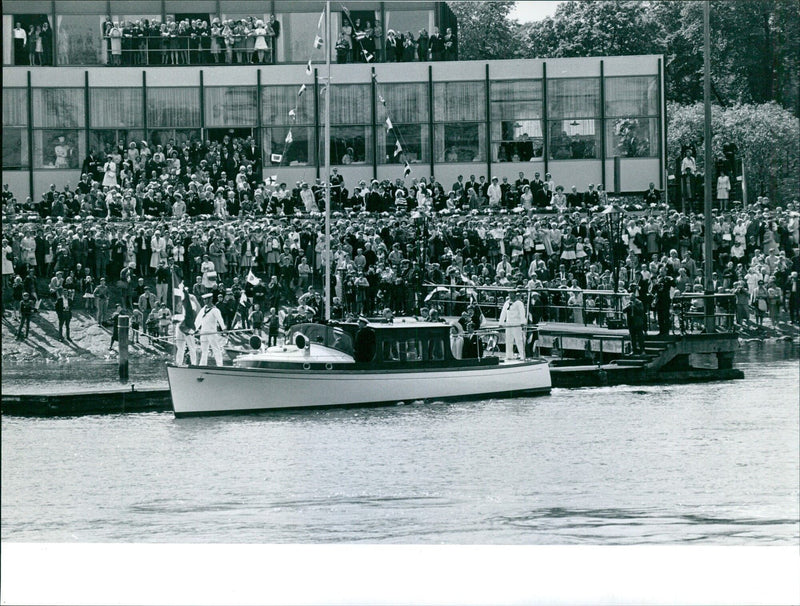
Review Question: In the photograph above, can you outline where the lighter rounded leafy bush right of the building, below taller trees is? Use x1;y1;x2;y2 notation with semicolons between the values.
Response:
667;102;800;201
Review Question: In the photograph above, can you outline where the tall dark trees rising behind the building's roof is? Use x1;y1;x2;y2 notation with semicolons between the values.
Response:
450;0;800;115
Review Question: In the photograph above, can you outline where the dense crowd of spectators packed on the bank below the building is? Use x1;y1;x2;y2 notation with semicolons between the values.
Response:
2;137;800;350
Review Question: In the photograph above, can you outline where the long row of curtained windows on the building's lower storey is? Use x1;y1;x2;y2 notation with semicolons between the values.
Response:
3;46;664;194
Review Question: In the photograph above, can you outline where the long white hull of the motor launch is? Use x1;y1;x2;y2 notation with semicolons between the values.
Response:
162;360;551;417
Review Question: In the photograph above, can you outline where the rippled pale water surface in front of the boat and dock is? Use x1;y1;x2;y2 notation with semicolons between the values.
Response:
2;343;800;545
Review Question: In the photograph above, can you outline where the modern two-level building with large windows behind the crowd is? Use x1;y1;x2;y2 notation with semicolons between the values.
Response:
3;0;665;199
